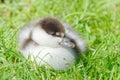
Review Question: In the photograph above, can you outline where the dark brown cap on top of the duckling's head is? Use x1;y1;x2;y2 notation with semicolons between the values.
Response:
38;18;65;37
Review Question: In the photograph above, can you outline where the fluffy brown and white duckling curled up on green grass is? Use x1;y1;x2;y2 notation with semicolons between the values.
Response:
18;17;87;70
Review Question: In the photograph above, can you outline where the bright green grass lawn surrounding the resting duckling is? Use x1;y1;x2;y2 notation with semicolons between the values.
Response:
0;0;120;80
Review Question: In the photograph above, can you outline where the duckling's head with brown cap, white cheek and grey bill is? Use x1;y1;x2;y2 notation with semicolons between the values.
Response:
31;18;75;47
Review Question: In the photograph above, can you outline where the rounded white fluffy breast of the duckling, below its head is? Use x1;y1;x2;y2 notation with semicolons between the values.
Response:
21;43;77;70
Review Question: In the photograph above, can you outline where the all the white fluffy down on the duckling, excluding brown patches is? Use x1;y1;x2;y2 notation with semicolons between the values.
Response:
19;18;86;70
